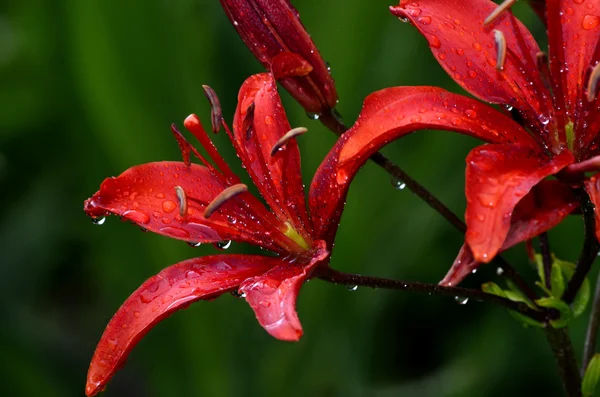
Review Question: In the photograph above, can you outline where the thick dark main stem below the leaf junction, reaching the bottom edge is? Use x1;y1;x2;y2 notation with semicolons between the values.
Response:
544;327;581;397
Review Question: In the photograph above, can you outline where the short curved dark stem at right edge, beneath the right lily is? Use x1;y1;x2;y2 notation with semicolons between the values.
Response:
561;189;599;304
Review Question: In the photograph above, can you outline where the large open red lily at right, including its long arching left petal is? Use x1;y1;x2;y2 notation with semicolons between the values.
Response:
312;0;600;285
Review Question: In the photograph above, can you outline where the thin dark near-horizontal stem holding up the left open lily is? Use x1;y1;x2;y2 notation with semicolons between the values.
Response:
314;267;553;323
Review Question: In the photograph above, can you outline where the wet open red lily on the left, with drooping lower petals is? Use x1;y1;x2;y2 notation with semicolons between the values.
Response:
85;73;344;396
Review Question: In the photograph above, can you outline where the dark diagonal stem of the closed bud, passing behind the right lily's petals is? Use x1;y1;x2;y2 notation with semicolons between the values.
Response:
319;109;537;302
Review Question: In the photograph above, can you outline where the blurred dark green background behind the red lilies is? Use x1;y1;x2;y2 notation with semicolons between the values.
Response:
0;0;587;397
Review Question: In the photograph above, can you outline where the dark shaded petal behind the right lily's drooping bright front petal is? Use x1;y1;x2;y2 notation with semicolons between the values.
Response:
440;180;579;286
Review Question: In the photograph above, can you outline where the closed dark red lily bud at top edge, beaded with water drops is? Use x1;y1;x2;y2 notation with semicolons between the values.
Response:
221;0;337;114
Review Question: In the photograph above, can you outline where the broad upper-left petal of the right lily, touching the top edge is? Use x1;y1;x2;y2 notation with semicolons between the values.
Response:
391;0;552;133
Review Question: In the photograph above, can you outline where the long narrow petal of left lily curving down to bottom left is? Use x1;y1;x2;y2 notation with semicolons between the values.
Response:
85;255;280;396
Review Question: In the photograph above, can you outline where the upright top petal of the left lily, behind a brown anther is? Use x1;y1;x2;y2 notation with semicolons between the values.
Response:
233;73;312;240
